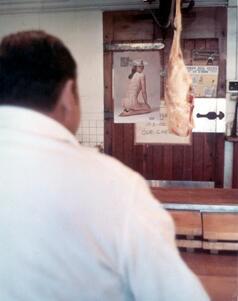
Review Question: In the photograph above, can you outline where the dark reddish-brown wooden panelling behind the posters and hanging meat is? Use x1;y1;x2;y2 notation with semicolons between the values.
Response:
104;8;226;187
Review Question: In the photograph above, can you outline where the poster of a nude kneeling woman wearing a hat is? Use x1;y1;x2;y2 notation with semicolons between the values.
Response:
112;51;160;123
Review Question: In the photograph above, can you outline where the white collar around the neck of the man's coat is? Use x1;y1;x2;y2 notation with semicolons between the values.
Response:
0;105;79;146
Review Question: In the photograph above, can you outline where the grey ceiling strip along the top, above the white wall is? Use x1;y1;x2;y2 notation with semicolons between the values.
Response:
0;0;228;14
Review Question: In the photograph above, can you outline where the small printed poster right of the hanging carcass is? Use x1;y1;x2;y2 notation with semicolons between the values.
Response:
187;66;219;97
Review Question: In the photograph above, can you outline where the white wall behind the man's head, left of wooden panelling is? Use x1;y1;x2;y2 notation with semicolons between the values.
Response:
0;11;104;146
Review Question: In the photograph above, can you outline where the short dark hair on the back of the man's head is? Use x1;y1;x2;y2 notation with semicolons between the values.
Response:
0;31;76;111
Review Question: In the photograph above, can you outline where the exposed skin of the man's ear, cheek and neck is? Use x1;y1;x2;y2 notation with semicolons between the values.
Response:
51;79;79;133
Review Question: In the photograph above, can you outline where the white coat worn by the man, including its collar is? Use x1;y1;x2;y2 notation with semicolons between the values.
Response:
0;106;208;301
